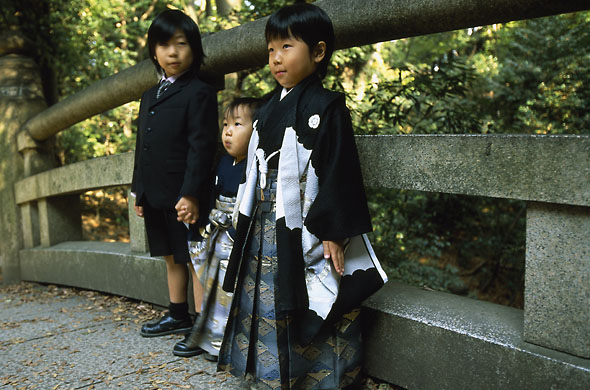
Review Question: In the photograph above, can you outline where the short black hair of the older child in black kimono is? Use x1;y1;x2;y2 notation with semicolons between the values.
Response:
264;3;335;78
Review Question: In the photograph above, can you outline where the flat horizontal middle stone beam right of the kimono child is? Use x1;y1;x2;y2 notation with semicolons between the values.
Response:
357;135;590;206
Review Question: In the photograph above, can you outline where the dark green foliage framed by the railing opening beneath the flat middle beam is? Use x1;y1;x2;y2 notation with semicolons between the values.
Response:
369;190;526;306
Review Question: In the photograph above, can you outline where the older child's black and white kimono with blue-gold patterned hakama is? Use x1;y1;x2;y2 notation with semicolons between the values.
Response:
219;74;386;389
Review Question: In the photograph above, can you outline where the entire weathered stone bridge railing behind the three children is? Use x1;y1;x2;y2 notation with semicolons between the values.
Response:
0;0;590;389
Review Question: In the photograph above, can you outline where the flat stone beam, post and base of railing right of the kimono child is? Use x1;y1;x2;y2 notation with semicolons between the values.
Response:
359;135;590;389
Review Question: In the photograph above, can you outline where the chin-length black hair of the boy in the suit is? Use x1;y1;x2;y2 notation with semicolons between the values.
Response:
148;9;205;73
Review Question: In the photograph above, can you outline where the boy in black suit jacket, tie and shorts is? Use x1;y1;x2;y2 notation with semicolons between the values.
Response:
131;10;218;337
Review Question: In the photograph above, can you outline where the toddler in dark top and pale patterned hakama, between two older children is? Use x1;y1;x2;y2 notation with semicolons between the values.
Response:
173;98;261;361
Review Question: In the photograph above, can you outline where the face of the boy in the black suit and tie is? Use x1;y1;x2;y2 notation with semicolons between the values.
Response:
155;30;193;77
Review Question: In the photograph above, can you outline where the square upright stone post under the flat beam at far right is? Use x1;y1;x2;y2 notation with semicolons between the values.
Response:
524;203;590;358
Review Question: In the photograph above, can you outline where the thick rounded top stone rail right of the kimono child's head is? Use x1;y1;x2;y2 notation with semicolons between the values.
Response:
324;0;589;51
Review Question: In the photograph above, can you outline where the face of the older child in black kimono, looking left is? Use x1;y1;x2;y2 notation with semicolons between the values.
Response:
267;36;326;89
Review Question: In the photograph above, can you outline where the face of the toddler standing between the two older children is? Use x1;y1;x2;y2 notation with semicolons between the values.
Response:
221;105;252;161
